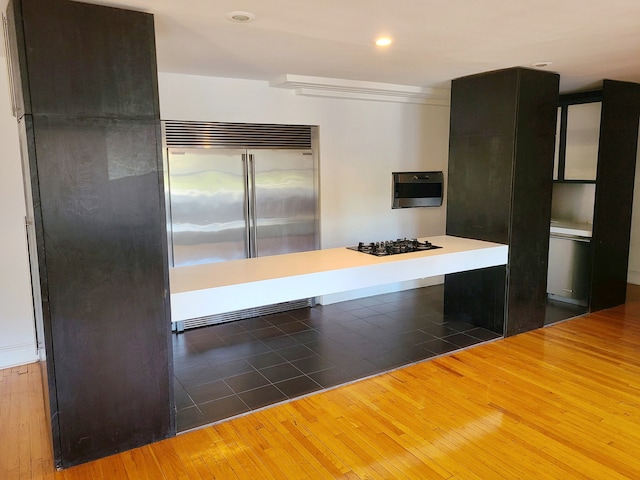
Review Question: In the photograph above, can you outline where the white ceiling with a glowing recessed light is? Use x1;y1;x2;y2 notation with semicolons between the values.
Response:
13;0;640;93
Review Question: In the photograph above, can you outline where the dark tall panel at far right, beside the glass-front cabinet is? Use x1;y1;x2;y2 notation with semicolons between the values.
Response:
589;80;640;311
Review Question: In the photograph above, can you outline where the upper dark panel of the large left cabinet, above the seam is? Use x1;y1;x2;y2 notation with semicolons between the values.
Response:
8;0;158;117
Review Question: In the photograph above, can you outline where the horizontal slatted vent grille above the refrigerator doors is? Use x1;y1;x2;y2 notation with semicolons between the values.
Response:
162;120;313;148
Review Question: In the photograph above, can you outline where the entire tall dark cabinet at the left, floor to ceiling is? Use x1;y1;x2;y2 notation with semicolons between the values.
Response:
7;0;175;467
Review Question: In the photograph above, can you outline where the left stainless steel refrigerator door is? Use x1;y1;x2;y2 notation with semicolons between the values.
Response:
168;148;248;267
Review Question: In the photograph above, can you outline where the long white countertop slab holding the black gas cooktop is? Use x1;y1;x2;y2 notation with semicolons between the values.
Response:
170;235;508;322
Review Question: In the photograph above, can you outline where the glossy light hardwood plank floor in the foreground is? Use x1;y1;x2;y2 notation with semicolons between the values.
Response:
0;287;640;480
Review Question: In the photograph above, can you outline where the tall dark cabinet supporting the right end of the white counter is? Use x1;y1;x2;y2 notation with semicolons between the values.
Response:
444;68;559;335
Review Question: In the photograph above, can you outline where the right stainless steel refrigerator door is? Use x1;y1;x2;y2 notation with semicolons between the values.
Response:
248;149;318;257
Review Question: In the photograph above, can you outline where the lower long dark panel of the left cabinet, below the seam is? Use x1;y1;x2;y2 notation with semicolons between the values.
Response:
34;117;171;466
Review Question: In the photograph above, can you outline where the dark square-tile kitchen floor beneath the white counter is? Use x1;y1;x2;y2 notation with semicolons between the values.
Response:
173;285;499;431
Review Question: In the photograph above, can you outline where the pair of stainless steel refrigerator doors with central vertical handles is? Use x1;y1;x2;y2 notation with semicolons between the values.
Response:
167;148;318;267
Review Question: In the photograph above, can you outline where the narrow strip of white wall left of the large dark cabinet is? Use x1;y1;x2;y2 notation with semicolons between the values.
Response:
0;57;37;368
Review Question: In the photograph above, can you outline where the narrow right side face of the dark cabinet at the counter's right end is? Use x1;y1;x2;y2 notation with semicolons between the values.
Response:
505;70;559;335
